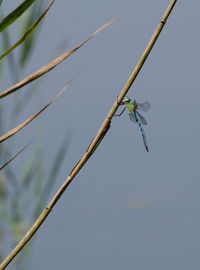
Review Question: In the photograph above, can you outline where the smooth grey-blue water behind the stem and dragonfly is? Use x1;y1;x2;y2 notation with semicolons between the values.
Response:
1;0;200;270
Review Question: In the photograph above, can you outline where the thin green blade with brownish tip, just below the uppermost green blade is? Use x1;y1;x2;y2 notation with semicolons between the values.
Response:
0;0;55;60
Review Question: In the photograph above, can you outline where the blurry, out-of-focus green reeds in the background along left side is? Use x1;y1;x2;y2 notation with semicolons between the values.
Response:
0;0;70;270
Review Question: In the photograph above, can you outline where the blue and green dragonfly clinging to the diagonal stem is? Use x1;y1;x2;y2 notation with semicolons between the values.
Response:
115;96;151;152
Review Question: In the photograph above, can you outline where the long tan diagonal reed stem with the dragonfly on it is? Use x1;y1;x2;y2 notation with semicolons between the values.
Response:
0;0;177;270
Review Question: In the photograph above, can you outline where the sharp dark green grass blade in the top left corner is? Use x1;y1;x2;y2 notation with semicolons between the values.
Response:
0;0;35;32
